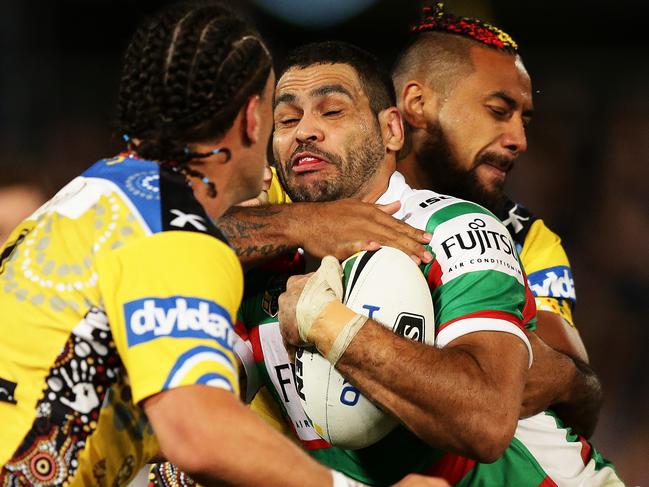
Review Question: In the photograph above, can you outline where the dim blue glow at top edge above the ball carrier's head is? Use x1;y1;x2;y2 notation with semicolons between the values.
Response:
254;0;376;28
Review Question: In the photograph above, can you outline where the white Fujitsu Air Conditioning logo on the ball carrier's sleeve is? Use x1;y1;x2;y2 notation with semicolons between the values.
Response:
431;213;523;284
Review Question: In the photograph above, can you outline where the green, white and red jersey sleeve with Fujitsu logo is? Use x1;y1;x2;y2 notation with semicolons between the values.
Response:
424;202;536;364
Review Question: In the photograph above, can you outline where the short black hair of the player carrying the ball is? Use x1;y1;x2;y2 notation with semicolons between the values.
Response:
277;41;397;115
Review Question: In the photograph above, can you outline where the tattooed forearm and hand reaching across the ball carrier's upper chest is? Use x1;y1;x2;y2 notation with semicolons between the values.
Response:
217;199;432;267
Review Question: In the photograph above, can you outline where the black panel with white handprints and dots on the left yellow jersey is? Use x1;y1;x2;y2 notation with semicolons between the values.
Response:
0;307;123;485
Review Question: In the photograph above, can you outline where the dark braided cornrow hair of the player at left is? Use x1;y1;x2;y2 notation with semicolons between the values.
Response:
117;2;272;177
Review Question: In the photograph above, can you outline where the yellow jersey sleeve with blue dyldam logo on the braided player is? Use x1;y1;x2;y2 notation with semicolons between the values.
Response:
97;231;243;403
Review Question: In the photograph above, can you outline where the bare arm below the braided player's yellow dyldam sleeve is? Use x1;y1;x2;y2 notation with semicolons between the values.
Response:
145;386;331;487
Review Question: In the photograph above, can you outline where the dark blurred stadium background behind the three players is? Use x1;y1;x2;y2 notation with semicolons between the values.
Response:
0;0;649;485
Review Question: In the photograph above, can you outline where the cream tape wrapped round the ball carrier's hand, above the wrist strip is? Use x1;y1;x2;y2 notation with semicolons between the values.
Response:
295;255;343;342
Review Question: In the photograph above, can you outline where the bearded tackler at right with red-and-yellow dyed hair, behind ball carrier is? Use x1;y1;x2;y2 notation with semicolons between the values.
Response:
393;4;602;437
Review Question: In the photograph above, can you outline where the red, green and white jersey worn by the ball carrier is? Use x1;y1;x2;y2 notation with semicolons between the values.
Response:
240;173;619;486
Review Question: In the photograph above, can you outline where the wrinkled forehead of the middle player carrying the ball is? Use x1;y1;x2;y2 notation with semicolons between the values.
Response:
275;63;365;107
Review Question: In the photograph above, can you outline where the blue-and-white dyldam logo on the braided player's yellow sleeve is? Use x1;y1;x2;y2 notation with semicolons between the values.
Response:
124;296;233;348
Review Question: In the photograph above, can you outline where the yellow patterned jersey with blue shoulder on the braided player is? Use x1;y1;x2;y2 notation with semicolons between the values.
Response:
0;155;243;485
